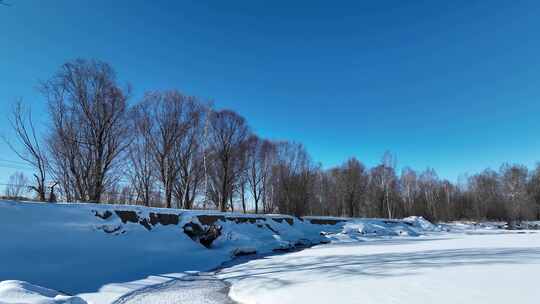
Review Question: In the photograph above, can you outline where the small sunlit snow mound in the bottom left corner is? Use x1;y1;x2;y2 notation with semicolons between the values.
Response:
0;280;86;304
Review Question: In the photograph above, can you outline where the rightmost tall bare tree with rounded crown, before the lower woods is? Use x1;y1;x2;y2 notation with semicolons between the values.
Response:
207;110;249;211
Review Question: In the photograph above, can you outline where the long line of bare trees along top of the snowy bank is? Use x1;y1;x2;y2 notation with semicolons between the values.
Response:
8;60;540;220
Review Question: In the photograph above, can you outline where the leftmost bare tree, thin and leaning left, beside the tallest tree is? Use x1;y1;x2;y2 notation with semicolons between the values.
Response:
4;101;48;201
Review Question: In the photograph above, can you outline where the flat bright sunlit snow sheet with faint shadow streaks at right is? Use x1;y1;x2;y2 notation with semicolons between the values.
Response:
218;232;540;304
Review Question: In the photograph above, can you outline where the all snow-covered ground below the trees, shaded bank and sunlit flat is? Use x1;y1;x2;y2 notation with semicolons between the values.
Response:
0;201;540;304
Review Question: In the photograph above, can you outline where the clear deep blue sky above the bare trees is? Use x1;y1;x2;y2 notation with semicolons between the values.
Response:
0;0;540;182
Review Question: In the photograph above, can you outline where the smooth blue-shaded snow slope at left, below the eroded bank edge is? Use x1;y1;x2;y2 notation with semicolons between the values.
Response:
0;202;226;302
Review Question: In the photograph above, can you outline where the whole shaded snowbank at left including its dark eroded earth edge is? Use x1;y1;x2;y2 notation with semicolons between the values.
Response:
0;201;338;303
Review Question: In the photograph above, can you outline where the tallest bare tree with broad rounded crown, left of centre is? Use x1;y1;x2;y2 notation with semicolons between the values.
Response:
42;59;130;202
